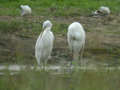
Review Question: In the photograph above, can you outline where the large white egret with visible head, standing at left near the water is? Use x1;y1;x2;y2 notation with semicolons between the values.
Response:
35;20;54;66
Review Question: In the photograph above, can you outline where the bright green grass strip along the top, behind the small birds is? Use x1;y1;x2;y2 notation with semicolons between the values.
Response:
0;0;120;16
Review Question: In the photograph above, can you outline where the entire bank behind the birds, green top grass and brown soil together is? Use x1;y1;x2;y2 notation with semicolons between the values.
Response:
0;0;120;65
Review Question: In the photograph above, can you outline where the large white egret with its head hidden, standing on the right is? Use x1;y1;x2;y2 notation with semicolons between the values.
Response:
67;22;86;63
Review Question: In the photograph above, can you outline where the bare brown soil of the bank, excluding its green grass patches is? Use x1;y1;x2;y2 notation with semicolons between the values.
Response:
0;15;120;65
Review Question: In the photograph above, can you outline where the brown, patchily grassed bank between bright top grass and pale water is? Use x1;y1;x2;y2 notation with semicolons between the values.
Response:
0;15;120;65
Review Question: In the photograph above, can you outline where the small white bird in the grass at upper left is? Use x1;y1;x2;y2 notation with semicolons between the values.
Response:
20;5;32;16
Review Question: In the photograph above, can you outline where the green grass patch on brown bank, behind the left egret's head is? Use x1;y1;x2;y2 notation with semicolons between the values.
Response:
0;18;68;34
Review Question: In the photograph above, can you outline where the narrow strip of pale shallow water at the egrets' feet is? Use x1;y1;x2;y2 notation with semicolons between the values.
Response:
0;64;120;75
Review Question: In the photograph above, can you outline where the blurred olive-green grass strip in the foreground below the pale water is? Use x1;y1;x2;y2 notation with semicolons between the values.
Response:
0;69;120;90
